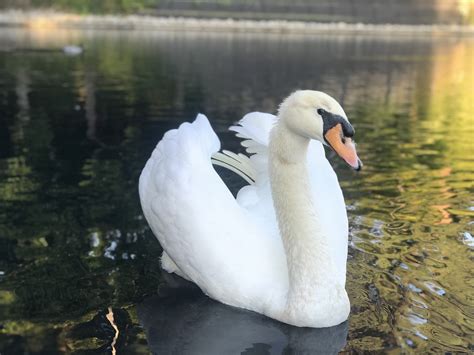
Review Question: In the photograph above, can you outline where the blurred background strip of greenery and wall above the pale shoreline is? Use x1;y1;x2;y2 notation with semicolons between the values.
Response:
0;0;474;25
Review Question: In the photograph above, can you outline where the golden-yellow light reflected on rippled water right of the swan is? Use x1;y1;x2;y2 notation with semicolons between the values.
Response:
346;41;474;353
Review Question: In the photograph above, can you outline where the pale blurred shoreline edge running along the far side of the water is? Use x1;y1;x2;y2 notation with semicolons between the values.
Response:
0;10;474;37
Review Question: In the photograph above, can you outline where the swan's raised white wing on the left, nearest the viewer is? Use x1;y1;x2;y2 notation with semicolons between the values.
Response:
139;115;287;313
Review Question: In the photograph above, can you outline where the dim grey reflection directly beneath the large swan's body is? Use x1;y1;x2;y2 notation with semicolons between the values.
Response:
138;280;347;355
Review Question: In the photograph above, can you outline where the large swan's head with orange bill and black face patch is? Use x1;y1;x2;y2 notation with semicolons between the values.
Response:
278;90;362;170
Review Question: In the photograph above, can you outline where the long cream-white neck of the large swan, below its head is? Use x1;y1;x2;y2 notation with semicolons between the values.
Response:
269;121;344;311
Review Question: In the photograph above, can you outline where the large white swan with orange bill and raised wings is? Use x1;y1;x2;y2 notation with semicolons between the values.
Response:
139;90;362;328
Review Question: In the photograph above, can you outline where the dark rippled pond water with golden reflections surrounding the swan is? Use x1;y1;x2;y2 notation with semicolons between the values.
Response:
0;29;474;354
